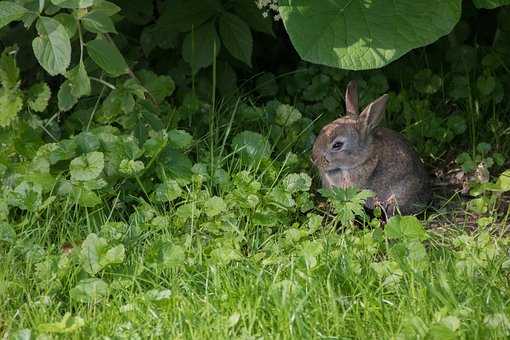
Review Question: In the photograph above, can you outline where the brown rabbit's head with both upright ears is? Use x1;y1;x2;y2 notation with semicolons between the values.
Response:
312;81;388;171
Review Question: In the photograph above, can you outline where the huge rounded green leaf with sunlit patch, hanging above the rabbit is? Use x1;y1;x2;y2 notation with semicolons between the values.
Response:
280;0;461;70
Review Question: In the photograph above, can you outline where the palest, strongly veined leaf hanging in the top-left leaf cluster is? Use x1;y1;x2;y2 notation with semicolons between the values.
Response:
32;17;71;76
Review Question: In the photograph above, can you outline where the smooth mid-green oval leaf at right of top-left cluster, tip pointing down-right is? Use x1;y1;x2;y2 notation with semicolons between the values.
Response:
87;38;129;77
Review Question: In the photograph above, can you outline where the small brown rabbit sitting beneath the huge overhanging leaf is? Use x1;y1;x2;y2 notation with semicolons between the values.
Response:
312;81;430;216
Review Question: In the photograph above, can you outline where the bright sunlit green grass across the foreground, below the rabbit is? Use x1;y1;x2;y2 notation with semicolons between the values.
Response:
0;197;510;339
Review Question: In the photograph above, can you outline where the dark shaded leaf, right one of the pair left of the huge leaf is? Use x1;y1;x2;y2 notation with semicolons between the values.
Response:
219;12;253;67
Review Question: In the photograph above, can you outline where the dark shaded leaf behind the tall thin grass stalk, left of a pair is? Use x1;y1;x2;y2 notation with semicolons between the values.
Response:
182;21;221;73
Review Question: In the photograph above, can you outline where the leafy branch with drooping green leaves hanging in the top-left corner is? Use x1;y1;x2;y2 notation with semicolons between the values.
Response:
0;0;133;115
